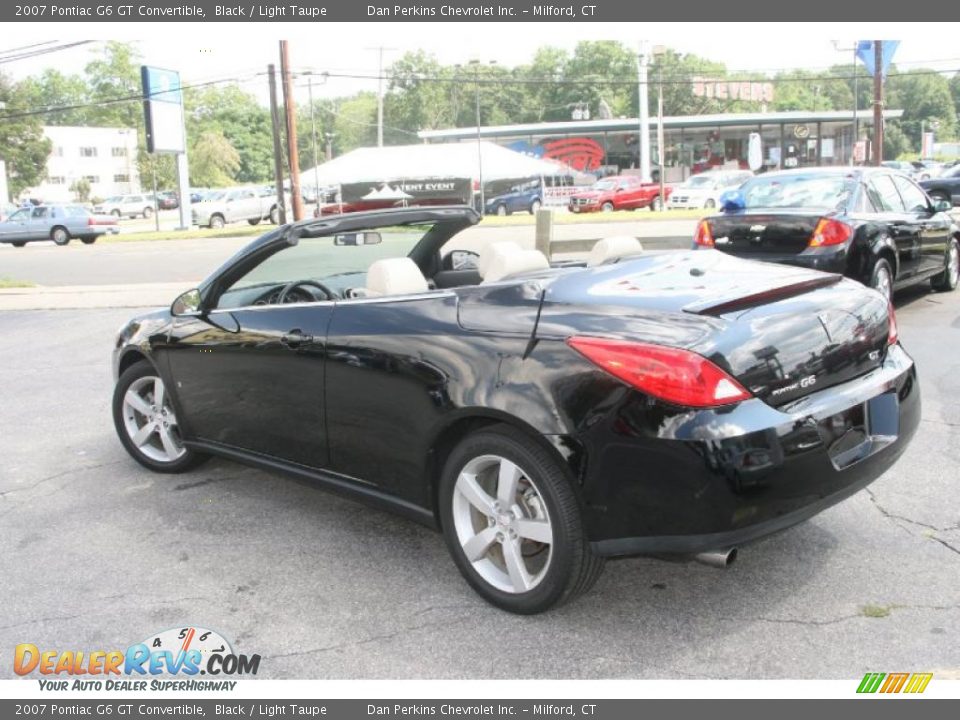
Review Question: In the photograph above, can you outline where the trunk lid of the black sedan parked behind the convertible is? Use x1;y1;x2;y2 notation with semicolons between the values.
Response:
707;208;824;257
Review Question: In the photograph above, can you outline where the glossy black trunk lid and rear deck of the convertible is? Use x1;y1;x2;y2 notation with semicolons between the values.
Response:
532;250;889;405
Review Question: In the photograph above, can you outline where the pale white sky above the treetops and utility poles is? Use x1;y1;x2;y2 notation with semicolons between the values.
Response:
0;22;960;107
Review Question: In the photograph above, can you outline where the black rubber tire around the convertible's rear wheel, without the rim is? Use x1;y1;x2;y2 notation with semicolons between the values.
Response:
439;425;604;615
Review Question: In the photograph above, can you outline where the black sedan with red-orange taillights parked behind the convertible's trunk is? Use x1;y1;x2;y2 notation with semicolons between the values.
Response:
694;168;960;297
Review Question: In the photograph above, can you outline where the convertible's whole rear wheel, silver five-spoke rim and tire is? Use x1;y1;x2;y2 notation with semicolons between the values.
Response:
441;427;603;614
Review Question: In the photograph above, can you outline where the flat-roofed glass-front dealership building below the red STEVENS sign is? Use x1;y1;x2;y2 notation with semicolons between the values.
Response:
418;110;903;182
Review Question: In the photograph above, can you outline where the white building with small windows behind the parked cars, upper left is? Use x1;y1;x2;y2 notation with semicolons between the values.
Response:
22;125;141;202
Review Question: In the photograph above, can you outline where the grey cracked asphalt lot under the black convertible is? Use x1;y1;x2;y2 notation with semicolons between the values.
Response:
0;282;960;679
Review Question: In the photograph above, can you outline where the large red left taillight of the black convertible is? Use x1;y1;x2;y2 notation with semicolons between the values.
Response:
567;337;751;407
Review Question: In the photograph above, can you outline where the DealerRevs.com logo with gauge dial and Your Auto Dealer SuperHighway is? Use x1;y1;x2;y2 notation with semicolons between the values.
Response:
13;627;260;690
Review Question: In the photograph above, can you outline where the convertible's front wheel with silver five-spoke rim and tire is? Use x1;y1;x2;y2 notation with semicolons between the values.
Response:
113;362;204;472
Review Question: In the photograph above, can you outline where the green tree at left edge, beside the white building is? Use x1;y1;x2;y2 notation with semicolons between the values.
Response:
0;74;52;200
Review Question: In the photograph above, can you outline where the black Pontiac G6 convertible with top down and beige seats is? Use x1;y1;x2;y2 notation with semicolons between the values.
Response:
113;207;920;613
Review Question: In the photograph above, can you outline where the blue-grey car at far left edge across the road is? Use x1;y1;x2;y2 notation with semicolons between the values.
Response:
0;205;119;247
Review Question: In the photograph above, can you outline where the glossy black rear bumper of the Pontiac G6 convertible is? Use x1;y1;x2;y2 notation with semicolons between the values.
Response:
584;345;920;555
